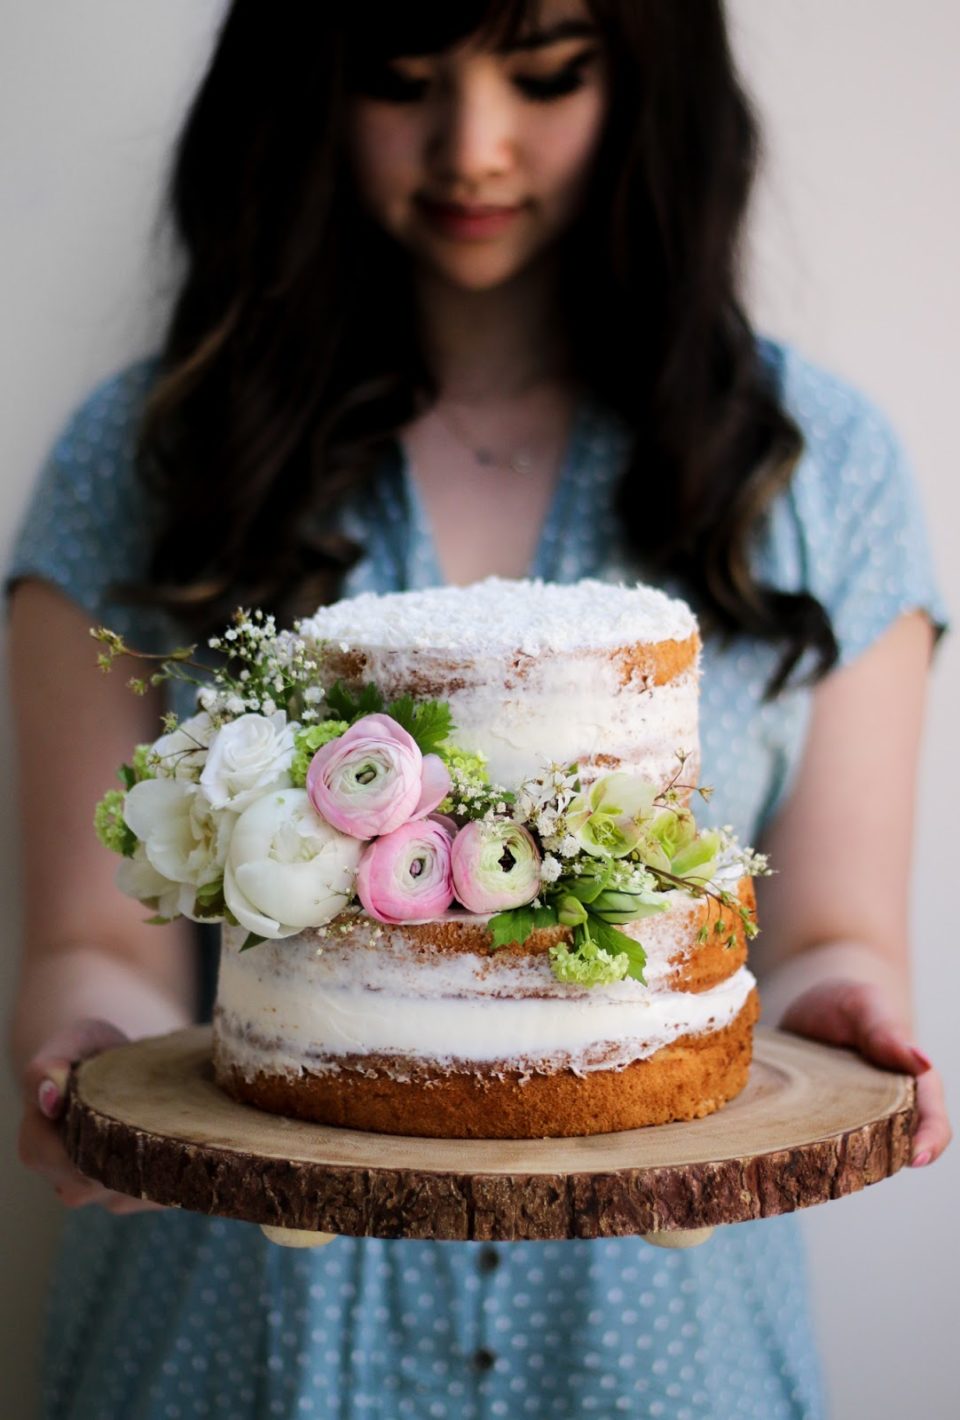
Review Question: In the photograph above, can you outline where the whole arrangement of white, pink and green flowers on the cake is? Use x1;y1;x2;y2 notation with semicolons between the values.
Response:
92;611;767;987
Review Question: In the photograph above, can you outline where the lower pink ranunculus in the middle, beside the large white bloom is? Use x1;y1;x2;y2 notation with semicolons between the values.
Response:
356;818;453;923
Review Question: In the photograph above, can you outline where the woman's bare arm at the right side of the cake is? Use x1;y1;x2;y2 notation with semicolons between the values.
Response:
753;612;950;1163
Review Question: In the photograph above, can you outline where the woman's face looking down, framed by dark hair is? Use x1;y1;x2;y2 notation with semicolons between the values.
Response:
351;0;606;291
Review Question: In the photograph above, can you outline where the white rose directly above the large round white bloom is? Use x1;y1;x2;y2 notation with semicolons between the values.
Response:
200;710;298;814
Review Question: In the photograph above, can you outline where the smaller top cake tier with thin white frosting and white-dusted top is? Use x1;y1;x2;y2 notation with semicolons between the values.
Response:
300;578;700;790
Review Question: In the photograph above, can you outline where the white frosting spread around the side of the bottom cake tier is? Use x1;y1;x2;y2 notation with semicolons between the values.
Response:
216;919;754;1075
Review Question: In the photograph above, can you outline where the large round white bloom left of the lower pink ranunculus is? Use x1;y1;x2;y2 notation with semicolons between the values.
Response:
223;790;365;939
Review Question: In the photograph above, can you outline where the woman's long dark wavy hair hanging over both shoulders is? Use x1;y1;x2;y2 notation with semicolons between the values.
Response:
134;0;836;694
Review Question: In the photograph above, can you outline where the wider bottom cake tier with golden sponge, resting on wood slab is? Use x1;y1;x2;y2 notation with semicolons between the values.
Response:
213;883;758;1139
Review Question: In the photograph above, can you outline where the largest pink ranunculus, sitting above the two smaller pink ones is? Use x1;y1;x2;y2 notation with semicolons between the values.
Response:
307;714;450;838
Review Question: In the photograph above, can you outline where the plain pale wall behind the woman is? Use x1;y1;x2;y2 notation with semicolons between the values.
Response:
0;0;960;1420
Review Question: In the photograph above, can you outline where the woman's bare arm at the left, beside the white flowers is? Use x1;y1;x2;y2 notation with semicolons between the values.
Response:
10;581;195;1211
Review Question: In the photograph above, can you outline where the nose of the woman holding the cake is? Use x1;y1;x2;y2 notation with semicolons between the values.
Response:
430;75;516;186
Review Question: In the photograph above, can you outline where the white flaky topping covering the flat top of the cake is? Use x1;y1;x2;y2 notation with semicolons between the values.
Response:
300;577;697;655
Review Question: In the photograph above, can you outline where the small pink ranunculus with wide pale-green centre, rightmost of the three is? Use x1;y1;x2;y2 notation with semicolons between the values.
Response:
450;819;540;912
